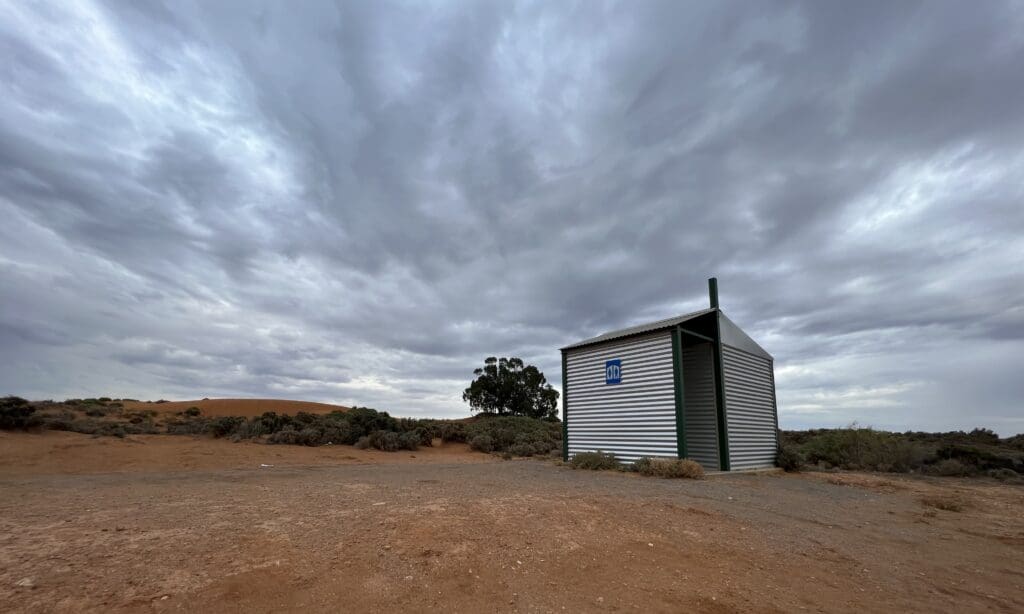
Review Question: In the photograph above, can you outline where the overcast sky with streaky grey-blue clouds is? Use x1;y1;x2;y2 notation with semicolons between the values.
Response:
0;0;1024;435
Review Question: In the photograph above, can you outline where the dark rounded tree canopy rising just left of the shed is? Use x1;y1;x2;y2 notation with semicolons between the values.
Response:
462;356;558;418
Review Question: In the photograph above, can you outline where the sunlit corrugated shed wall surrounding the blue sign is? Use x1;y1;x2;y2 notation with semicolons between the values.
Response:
565;331;678;462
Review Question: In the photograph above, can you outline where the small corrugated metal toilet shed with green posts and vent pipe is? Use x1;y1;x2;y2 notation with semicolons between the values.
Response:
561;279;778;471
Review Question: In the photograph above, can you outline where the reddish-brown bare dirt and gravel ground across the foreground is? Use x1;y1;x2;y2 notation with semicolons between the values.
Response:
0;434;1024;612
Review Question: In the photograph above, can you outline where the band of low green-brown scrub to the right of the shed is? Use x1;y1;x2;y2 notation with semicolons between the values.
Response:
777;425;1024;480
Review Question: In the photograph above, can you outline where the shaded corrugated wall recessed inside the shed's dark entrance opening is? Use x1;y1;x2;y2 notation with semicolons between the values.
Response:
682;343;719;471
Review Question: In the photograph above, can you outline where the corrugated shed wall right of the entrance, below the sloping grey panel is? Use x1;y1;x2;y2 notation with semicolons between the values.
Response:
722;346;778;471
